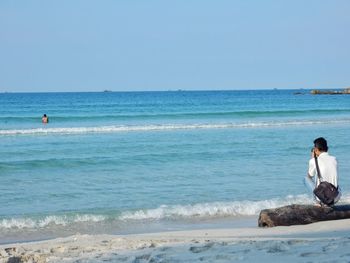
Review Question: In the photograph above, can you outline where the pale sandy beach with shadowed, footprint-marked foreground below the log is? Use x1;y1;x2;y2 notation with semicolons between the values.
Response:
0;219;350;263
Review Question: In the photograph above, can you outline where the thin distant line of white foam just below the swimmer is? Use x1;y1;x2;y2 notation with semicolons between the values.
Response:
0;119;350;135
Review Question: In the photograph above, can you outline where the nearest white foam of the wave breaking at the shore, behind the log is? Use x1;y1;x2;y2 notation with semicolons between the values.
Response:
0;194;350;230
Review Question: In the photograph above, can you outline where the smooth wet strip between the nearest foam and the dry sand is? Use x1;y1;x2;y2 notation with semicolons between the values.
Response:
0;215;258;247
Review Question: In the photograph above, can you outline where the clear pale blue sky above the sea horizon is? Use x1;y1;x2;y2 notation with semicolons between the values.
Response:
0;0;350;92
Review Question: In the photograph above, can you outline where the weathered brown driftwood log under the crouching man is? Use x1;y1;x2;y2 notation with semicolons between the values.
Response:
258;205;350;227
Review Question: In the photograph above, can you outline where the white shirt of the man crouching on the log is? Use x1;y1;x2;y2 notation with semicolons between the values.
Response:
309;152;338;187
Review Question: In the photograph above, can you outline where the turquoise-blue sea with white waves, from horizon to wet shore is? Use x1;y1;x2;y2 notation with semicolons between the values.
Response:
0;90;350;243
